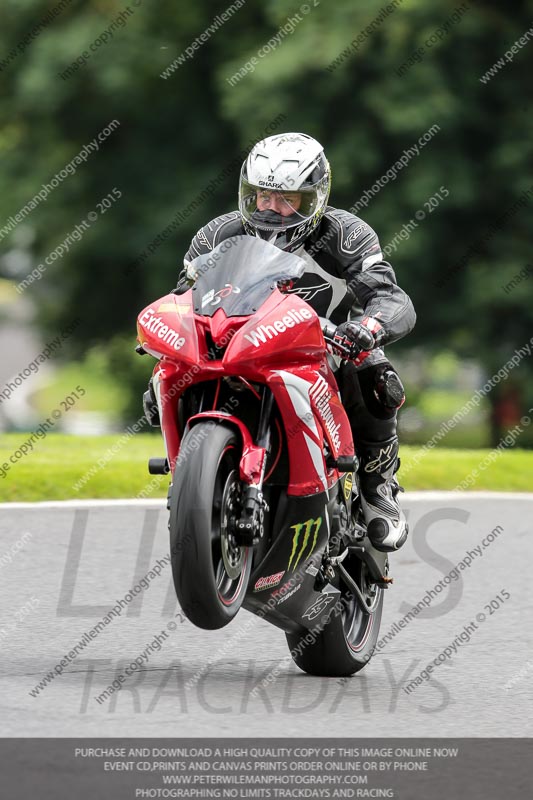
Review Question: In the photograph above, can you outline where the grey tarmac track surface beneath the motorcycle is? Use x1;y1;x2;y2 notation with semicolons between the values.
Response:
0;492;533;737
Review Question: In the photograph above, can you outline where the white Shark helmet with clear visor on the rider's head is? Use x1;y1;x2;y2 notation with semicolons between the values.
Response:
239;133;331;251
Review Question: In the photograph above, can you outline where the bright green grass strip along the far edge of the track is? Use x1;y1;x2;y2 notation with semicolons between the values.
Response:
0;433;533;502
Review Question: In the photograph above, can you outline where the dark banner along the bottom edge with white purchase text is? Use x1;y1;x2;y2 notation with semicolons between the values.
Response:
0;738;532;800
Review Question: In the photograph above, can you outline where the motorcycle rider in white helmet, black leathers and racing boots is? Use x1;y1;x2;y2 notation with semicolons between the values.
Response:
145;133;416;552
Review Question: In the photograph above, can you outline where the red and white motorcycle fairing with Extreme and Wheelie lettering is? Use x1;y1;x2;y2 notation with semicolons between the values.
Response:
137;289;354;496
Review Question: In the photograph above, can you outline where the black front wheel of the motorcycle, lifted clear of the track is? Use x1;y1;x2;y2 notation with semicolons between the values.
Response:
169;422;252;630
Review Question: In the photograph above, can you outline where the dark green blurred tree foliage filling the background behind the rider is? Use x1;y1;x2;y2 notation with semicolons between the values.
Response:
0;0;533;432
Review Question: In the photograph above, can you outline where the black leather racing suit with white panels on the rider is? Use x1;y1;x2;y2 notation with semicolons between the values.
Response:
184;206;416;450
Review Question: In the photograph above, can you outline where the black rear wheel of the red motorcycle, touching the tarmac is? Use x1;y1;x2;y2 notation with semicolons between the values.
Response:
286;556;383;677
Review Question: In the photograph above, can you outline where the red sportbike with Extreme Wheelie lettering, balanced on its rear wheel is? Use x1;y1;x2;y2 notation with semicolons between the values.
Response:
137;236;391;676
